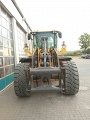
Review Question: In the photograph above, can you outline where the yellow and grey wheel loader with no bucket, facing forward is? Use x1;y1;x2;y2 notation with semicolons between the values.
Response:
14;30;79;97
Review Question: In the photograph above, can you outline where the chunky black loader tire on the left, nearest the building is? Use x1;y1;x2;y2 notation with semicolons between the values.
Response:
14;63;31;97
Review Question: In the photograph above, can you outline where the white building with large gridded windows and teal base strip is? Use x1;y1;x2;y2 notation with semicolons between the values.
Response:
0;0;31;91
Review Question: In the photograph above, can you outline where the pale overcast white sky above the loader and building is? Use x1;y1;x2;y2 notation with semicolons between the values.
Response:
15;0;90;51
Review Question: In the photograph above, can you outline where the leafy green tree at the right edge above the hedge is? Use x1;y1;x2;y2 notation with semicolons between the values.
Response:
79;33;90;51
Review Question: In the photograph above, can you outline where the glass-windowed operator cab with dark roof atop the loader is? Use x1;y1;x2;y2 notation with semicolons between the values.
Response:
28;31;62;49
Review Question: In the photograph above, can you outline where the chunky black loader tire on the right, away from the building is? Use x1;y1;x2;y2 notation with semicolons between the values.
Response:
63;61;79;95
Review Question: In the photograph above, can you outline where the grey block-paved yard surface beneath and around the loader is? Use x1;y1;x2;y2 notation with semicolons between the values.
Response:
0;58;90;120
